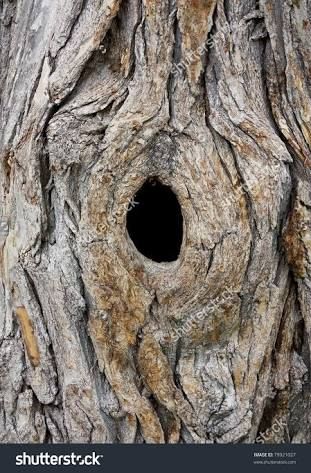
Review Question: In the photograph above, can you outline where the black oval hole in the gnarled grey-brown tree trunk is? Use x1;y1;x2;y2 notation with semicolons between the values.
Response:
127;179;183;263
